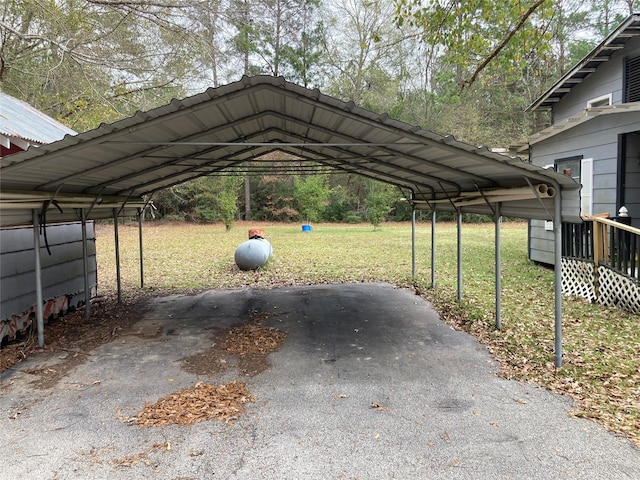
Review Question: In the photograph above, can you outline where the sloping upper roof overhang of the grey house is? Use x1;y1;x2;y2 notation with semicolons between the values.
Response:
525;13;640;111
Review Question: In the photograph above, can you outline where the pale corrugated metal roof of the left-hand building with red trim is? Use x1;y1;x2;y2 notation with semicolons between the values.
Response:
0;92;76;145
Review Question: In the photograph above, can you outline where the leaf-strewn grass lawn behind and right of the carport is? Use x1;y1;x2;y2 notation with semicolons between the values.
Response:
96;222;640;446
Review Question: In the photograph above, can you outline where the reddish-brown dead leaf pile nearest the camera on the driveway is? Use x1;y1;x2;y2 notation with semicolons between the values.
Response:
127;381;255;427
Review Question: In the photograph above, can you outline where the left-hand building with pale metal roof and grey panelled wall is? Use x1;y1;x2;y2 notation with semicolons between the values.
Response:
0;92;97;345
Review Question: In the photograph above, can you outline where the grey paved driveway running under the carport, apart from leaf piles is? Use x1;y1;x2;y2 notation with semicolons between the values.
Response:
0;284;640;480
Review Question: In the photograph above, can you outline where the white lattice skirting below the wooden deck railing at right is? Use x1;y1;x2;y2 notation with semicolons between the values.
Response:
562;258;640;315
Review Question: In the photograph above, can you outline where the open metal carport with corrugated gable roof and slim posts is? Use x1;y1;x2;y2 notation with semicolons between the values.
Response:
0;76;580;366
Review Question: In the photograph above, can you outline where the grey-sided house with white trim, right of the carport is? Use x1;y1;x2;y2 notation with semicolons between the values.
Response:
521;13;640;265
